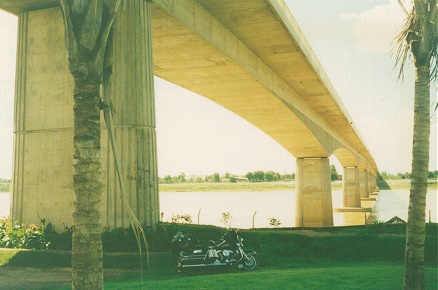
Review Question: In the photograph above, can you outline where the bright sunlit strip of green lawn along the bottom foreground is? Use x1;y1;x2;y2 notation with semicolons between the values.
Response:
100;262;437;290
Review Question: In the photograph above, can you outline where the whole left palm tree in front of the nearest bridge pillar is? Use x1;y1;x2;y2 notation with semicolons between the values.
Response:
60;0;121;289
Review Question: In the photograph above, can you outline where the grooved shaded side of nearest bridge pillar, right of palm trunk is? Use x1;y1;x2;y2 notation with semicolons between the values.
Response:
102;0;159;227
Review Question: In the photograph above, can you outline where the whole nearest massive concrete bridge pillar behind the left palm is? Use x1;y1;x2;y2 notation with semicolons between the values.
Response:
11;0;159;231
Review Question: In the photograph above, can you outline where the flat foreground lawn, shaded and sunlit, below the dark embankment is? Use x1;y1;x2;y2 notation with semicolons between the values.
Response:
0;249;438;290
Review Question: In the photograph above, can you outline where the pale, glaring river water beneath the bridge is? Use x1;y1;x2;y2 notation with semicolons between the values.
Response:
0;189;437;228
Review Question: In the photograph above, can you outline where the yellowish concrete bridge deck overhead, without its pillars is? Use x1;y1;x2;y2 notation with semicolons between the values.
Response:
0;0;378;172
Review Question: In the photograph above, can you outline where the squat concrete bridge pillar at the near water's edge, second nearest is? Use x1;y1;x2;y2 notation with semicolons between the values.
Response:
295;158;333;227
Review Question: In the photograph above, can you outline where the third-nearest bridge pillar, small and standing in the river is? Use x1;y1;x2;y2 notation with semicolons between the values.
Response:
342;167;361;207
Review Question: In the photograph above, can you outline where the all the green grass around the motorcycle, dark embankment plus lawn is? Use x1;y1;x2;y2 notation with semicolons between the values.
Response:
0;223;438;289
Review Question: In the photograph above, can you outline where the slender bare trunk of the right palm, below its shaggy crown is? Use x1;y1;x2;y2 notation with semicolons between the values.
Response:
404;65;430;290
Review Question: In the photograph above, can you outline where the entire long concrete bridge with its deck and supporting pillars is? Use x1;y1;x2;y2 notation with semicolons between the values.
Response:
0;0;378;230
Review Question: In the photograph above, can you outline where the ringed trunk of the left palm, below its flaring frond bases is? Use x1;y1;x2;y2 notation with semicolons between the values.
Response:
72;81;103;289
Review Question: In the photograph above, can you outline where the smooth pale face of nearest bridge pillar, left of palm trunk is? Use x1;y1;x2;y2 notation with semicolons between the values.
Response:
11;8;74;231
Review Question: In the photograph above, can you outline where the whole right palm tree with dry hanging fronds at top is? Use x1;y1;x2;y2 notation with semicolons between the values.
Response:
396;0;438;289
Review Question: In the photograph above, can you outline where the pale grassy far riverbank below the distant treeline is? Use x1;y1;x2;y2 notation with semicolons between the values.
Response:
159;179;437;192
